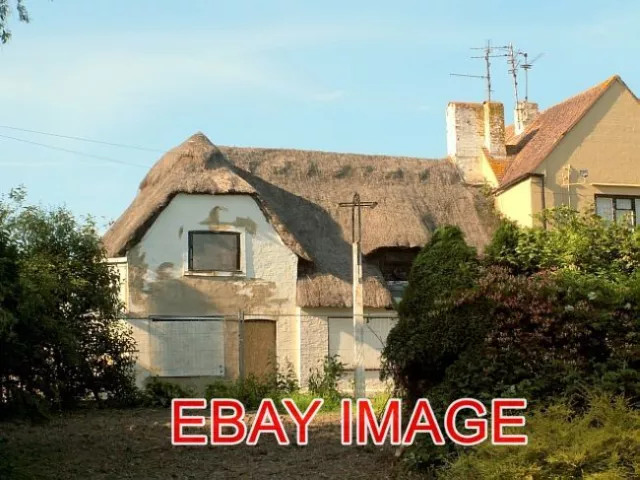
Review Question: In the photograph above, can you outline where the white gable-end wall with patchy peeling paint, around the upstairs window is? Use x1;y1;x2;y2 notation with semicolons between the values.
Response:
110;194;300;388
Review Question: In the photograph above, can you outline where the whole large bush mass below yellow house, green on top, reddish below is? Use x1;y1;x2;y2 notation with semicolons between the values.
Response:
383;209;640;408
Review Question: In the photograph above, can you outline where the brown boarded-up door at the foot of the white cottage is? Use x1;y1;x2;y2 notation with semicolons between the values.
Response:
244;320;276;377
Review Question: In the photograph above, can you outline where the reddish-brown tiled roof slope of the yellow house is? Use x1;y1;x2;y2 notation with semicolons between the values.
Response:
496;75;621;188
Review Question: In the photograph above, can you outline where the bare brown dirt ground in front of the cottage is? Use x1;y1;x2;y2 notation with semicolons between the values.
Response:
0;409;424;480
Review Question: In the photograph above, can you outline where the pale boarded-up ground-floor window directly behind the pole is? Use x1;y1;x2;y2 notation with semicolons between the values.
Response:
329;317;396;370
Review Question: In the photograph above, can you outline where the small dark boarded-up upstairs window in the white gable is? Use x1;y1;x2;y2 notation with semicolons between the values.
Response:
189;232;240;272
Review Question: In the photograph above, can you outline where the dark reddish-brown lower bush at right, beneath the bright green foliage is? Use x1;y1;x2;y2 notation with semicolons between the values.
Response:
392;268;640;407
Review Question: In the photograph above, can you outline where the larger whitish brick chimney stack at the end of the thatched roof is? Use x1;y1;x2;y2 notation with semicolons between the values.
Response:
447;102;506;183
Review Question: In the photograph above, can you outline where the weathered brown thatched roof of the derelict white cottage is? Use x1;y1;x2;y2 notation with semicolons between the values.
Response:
104;134;494;307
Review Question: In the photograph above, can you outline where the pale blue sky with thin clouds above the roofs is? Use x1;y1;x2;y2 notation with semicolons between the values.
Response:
0;0;640;227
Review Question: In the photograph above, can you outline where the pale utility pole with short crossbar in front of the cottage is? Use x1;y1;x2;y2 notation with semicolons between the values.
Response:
338;193;378;399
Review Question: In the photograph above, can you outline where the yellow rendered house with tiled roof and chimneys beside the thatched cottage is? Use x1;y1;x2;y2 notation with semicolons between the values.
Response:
447;75;640;226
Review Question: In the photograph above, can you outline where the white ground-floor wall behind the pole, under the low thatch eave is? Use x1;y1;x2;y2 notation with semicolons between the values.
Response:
300;308;397;394
